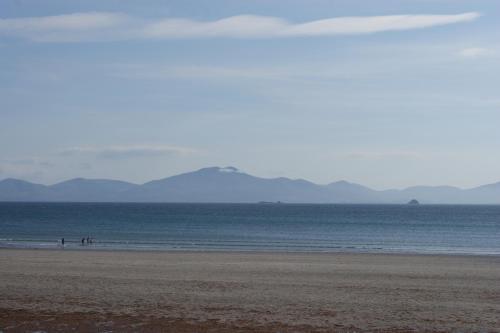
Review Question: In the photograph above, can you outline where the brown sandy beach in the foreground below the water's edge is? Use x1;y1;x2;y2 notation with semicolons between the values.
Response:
0;249;500;332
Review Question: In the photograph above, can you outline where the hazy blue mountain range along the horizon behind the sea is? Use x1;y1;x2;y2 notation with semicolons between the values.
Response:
0;167;500;204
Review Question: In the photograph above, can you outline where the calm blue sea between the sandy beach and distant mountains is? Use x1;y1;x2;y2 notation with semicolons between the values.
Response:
0;203;500;254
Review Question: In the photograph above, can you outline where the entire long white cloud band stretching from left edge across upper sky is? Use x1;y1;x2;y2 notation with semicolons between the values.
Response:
0;12;480;42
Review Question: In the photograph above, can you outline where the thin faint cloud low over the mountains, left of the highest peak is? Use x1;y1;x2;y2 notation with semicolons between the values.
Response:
60;145;196;159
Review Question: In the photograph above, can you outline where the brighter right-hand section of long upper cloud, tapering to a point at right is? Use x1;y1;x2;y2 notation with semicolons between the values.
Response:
140;12;480;38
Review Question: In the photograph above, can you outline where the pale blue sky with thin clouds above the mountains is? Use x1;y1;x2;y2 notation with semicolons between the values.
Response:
0;0;500;189
